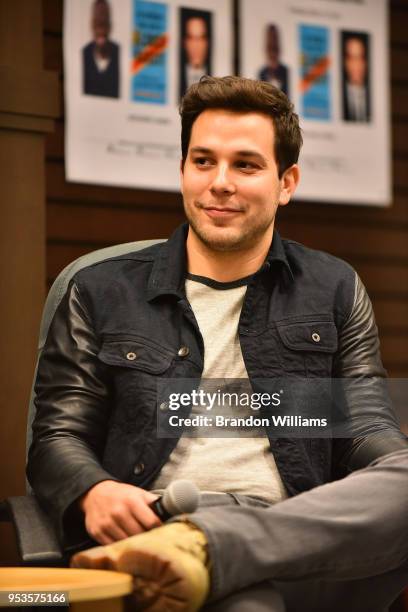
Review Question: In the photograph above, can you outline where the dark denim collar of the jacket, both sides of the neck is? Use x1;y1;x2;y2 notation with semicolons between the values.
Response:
147;223;294;301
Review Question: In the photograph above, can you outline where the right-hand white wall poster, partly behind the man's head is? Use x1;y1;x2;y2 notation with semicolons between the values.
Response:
239;0;391;206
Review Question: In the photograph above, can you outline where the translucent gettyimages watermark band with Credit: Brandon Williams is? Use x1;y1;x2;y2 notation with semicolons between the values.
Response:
157;377;404;438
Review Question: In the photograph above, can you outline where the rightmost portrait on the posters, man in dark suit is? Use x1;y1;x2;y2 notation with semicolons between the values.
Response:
341;31;371;122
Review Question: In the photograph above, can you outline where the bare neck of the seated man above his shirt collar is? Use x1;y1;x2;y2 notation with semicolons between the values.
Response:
186;228;273;283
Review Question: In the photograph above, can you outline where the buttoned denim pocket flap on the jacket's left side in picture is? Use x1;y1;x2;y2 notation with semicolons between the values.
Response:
98;338;173;374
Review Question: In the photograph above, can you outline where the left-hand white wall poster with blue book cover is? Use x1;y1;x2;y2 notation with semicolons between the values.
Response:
64;0;233;191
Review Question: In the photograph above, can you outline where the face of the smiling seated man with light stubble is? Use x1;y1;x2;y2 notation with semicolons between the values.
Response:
181;109;290;251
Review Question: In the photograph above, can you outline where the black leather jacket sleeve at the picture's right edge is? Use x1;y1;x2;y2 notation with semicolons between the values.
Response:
333;274;408;476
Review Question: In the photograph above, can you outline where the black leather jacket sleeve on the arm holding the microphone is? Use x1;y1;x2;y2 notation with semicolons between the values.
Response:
27;281;117;544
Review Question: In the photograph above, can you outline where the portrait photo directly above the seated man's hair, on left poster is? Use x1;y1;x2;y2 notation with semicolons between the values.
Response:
179;8;212;99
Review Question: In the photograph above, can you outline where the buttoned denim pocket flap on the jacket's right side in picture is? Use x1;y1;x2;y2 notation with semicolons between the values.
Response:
277;321;338;353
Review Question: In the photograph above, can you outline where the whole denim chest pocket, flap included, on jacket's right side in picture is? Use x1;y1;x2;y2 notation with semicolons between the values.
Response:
276;320;338;377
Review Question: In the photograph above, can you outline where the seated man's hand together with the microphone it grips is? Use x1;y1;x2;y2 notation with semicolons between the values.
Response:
79;480;199;544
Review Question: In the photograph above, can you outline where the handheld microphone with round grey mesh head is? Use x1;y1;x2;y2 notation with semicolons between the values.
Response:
149;480;200;522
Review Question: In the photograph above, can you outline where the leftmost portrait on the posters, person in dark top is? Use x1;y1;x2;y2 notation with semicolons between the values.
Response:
82;0;120;98
